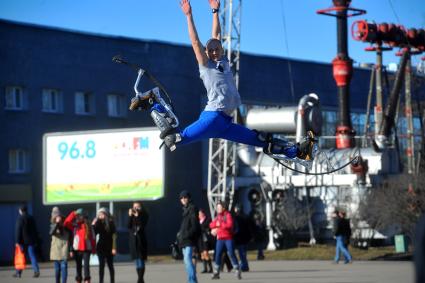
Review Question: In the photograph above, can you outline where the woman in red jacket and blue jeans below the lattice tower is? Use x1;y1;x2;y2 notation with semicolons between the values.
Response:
210;202;241;279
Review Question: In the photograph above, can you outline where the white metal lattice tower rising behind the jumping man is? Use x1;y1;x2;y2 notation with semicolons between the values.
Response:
208;0;242;219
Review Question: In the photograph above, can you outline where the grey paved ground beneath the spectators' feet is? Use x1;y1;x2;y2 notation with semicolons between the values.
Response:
0;261;414;283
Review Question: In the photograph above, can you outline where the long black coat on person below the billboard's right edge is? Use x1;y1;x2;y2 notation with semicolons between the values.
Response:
128;210;149;260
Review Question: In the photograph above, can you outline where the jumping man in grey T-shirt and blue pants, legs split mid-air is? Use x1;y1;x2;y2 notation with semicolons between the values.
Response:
149;0;313;163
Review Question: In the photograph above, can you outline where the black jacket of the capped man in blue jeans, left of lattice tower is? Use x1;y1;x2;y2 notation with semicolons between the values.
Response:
177;202;201;248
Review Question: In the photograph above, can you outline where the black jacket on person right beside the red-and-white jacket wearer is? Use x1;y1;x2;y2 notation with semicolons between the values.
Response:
93;219;117;256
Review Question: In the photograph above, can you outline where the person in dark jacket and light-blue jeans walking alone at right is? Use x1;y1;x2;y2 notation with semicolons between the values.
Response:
333;210;352;263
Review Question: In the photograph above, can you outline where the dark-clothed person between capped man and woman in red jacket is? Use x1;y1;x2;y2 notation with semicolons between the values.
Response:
198;209;213;273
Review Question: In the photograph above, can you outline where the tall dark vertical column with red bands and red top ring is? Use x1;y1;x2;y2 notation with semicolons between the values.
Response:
317;0;366;149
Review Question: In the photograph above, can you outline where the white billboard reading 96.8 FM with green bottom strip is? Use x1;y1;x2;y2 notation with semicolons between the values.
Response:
43;128;164;205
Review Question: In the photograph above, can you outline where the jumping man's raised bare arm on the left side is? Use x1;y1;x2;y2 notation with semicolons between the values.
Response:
180;0;208;66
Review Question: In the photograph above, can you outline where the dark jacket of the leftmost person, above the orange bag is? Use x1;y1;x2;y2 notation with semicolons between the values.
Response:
15;213;38;246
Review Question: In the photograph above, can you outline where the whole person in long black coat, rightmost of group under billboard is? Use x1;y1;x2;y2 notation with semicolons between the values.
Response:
127;201;149;283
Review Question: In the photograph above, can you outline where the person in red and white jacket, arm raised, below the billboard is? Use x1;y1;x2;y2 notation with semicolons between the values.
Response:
64;208;95;283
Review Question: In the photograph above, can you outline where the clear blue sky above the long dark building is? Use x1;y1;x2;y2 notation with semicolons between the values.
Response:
0;0;425;67
